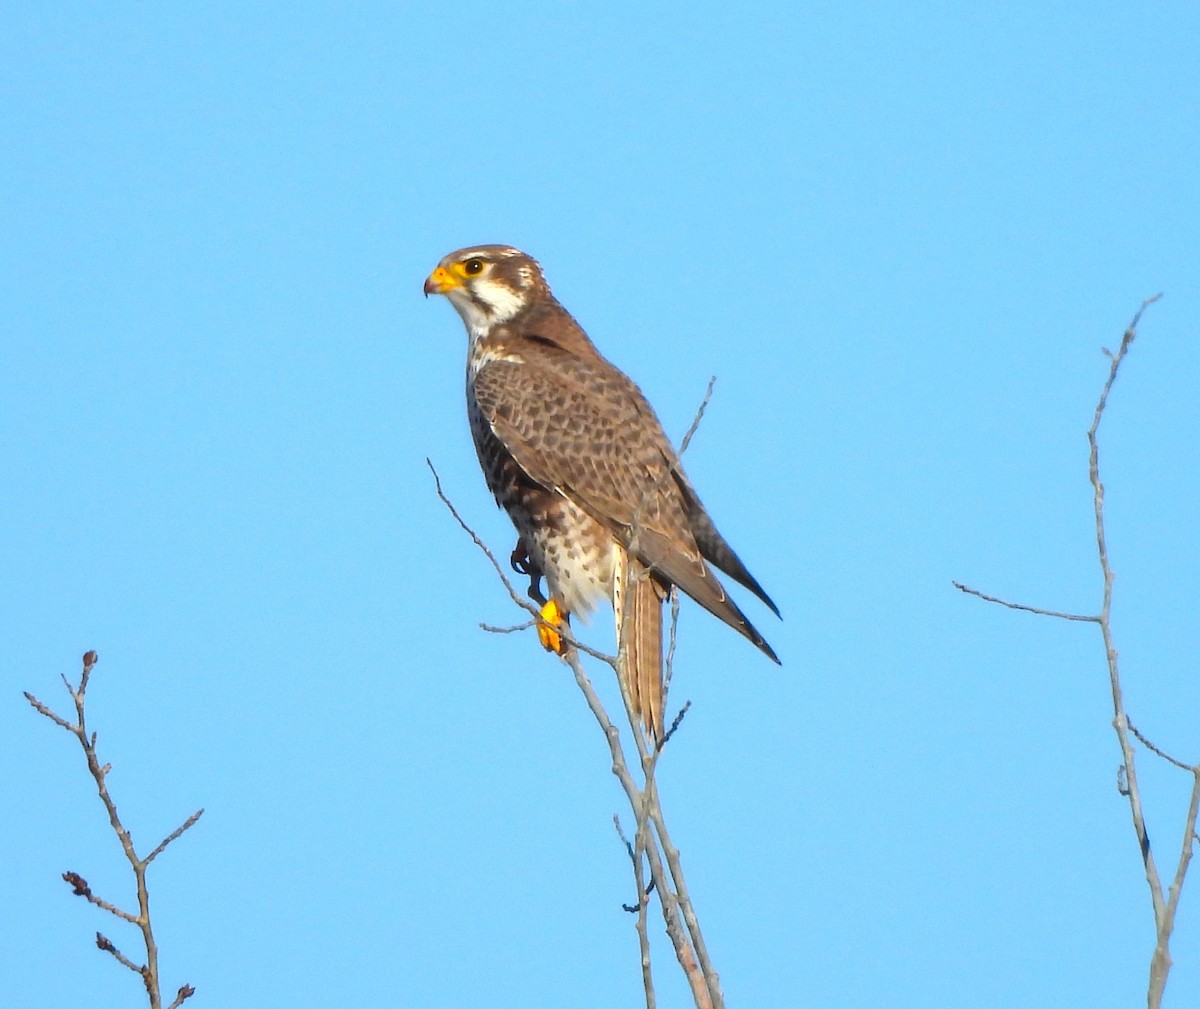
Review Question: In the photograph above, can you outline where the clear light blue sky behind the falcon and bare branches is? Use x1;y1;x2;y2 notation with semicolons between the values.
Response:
0;4;1200;1009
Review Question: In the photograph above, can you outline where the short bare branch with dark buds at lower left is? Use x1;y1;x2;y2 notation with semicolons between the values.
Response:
25;651;204;1009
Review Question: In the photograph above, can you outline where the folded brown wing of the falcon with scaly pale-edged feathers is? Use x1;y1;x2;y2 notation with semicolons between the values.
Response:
474;341;779;662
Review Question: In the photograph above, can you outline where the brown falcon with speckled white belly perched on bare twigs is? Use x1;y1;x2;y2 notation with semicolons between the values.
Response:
425;245;779;739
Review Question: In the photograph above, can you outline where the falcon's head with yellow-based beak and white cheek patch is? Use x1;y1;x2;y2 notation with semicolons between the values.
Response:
425;245;550;332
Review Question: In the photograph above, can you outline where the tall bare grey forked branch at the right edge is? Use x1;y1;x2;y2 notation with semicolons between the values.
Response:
954;294;1200;1009
